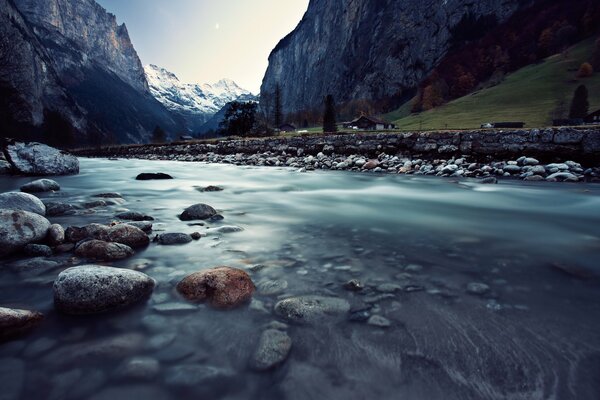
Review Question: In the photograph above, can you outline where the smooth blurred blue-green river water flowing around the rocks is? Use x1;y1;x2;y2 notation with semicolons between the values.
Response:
0;159;600;400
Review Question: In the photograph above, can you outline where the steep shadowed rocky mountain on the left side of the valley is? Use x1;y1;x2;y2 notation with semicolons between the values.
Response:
0;0;184;142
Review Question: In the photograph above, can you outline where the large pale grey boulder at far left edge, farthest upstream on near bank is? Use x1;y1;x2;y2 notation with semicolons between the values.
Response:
6;143;79;176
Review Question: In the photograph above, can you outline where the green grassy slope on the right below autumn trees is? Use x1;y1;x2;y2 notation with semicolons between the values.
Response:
384;38;600;130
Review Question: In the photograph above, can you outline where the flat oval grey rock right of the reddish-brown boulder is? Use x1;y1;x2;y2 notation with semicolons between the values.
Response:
275;296;350;323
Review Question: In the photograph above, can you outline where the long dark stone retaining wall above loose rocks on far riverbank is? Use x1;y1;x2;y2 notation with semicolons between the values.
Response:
76;127;600;166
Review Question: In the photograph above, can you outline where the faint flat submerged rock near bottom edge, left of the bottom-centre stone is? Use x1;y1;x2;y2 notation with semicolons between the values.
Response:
165;364;235;388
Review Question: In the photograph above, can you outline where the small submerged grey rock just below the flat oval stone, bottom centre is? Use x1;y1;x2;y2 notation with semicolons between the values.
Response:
251;329;292;371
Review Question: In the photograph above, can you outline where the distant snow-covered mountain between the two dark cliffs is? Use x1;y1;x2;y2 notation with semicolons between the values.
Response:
144;64;256;133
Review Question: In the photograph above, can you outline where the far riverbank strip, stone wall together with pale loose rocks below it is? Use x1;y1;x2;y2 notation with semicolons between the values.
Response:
76;128;600;183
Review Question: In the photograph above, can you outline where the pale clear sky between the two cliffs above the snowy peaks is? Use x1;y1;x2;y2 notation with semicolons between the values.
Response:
96;0;309;93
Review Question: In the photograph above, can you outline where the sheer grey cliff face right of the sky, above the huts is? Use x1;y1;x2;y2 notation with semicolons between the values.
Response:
261;0;523;113
